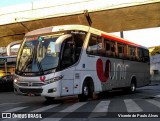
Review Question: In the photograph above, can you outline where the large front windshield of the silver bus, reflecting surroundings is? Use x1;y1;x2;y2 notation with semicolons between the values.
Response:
16;35;59;74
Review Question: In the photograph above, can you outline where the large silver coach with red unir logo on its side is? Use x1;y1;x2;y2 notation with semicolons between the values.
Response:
14;25;150;101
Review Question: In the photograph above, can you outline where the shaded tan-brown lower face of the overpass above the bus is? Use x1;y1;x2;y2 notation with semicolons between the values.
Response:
0;2;160;46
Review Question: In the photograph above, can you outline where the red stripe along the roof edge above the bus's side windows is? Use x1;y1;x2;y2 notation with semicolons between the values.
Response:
101;34;140;47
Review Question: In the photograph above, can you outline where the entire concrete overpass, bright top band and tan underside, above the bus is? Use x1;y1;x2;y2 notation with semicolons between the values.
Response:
0;0;160;46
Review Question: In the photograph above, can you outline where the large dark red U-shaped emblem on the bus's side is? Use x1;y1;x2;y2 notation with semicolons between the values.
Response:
96;58;111;82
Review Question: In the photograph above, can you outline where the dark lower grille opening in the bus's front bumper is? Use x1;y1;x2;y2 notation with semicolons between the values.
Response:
19;88;43;94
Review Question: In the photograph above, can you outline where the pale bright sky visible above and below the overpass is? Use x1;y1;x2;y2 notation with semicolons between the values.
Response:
0;0;160;47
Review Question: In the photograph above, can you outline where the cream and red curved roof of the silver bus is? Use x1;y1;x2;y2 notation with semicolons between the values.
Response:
25;25;147;49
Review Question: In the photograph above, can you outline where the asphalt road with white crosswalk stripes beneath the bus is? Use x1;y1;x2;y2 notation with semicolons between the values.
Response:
0;82;160;121
